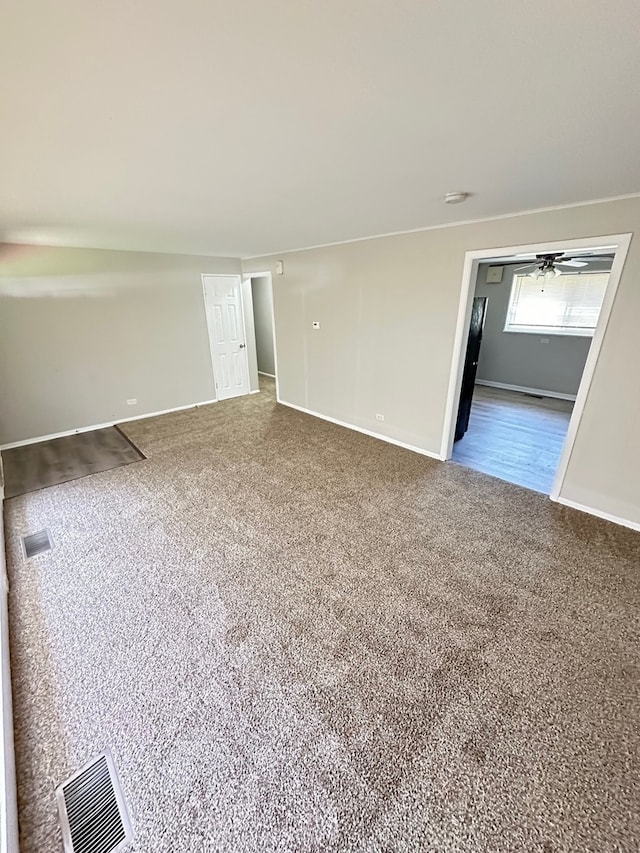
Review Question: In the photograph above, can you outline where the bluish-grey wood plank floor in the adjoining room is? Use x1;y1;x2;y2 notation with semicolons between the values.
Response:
453;385;573;494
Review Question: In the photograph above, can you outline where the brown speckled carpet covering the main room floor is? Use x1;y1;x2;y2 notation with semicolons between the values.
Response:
6;380;640;853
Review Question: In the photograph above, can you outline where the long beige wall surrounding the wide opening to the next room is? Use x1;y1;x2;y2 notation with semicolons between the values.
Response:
243;198;640;524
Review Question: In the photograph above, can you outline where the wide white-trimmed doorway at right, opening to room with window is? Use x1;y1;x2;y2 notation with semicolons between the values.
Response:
442;235;630;500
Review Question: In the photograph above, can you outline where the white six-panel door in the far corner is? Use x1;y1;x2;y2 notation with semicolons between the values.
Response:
202;275;249;400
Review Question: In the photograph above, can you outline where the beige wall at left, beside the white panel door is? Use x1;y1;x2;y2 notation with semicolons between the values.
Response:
0;245;240;444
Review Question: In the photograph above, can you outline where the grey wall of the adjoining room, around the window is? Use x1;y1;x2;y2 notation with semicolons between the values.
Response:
475;263;611;397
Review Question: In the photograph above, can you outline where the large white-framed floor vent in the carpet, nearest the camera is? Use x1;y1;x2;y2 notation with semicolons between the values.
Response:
56;750;133;853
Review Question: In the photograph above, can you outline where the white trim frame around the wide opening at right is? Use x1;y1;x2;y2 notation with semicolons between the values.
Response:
440;234;632;501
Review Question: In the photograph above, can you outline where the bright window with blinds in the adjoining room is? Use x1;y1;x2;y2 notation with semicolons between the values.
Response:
504;272;609;337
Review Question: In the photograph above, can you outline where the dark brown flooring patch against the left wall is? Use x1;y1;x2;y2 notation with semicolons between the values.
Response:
2;427;144;498
